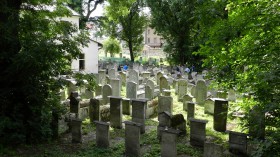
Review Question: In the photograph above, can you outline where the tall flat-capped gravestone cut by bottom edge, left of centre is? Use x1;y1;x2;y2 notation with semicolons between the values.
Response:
124;121;141;157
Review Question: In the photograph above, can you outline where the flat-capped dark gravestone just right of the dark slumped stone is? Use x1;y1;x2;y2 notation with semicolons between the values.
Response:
190;118;208;147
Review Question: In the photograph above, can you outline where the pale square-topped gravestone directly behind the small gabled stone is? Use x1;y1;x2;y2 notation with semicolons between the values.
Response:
158;96;173;115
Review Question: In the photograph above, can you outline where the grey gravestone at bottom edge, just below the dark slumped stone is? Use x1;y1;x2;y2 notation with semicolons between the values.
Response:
160;128;179;157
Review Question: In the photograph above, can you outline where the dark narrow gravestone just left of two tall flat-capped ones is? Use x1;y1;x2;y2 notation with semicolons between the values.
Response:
89;98;102;123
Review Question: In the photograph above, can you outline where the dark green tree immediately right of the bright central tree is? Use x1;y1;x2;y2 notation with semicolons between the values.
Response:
147;0;201;67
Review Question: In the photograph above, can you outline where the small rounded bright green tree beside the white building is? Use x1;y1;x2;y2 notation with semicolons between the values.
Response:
103;38;121;57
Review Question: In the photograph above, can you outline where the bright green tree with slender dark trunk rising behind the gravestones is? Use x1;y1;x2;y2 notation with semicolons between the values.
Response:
106;0;147;62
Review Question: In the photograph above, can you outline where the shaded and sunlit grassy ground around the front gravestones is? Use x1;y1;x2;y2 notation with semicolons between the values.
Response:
0;88;245;157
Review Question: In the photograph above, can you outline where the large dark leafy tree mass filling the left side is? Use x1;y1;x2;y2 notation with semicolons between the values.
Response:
0;1;88;144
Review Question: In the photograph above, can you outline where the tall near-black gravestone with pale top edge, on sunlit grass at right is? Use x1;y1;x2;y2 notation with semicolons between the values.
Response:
213;99;228;132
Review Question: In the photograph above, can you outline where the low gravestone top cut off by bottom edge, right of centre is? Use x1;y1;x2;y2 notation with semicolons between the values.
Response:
203;142;224;157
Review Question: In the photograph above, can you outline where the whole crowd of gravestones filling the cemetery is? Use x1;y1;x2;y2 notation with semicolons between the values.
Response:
56;64;263;156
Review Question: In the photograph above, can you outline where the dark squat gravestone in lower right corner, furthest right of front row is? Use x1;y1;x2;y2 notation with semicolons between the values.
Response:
228;131;247;156
